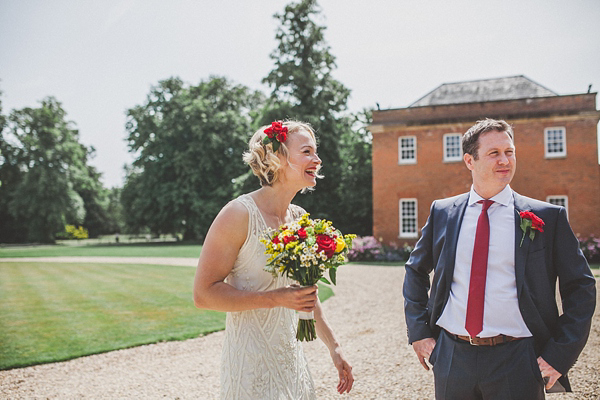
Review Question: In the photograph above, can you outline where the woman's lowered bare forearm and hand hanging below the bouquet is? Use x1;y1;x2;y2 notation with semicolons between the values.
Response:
315;301;354;394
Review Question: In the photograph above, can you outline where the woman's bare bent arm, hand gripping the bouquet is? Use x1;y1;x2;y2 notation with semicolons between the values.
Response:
194;201;317;311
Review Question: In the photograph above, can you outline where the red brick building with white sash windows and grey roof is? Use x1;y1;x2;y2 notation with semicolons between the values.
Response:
369;76;600;245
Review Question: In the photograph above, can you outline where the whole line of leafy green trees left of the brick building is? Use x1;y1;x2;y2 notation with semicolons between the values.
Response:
0;0;372;242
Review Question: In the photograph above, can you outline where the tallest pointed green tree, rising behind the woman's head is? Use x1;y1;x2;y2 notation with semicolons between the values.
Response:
261;0;372;234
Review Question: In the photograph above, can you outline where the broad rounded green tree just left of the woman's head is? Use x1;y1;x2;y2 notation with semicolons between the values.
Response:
121;77;264;240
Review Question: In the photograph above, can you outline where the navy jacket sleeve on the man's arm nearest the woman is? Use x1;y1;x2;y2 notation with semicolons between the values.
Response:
403;202;435;344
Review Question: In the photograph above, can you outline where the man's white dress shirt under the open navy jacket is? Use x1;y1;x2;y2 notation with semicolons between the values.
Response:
437;185;531;337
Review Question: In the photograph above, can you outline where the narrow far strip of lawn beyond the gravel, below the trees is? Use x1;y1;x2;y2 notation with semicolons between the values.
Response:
0;243;202;259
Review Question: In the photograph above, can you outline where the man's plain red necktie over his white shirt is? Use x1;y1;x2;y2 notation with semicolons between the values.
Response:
465;200;493;337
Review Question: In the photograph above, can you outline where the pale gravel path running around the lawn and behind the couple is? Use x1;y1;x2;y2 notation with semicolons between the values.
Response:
0;257;600;400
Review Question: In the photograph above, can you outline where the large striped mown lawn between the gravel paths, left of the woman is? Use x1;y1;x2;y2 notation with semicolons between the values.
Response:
0;262;225;369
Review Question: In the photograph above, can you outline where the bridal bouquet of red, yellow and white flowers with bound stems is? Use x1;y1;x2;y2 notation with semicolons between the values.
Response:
261;213;356;341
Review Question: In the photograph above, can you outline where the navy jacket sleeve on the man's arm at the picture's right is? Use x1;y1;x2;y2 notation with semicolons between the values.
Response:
541;208;596;375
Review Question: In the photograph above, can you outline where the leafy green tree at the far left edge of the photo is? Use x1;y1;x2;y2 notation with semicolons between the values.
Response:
0;97;91;242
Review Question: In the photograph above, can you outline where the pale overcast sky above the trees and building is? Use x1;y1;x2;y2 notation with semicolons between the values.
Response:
0;0;600;187
